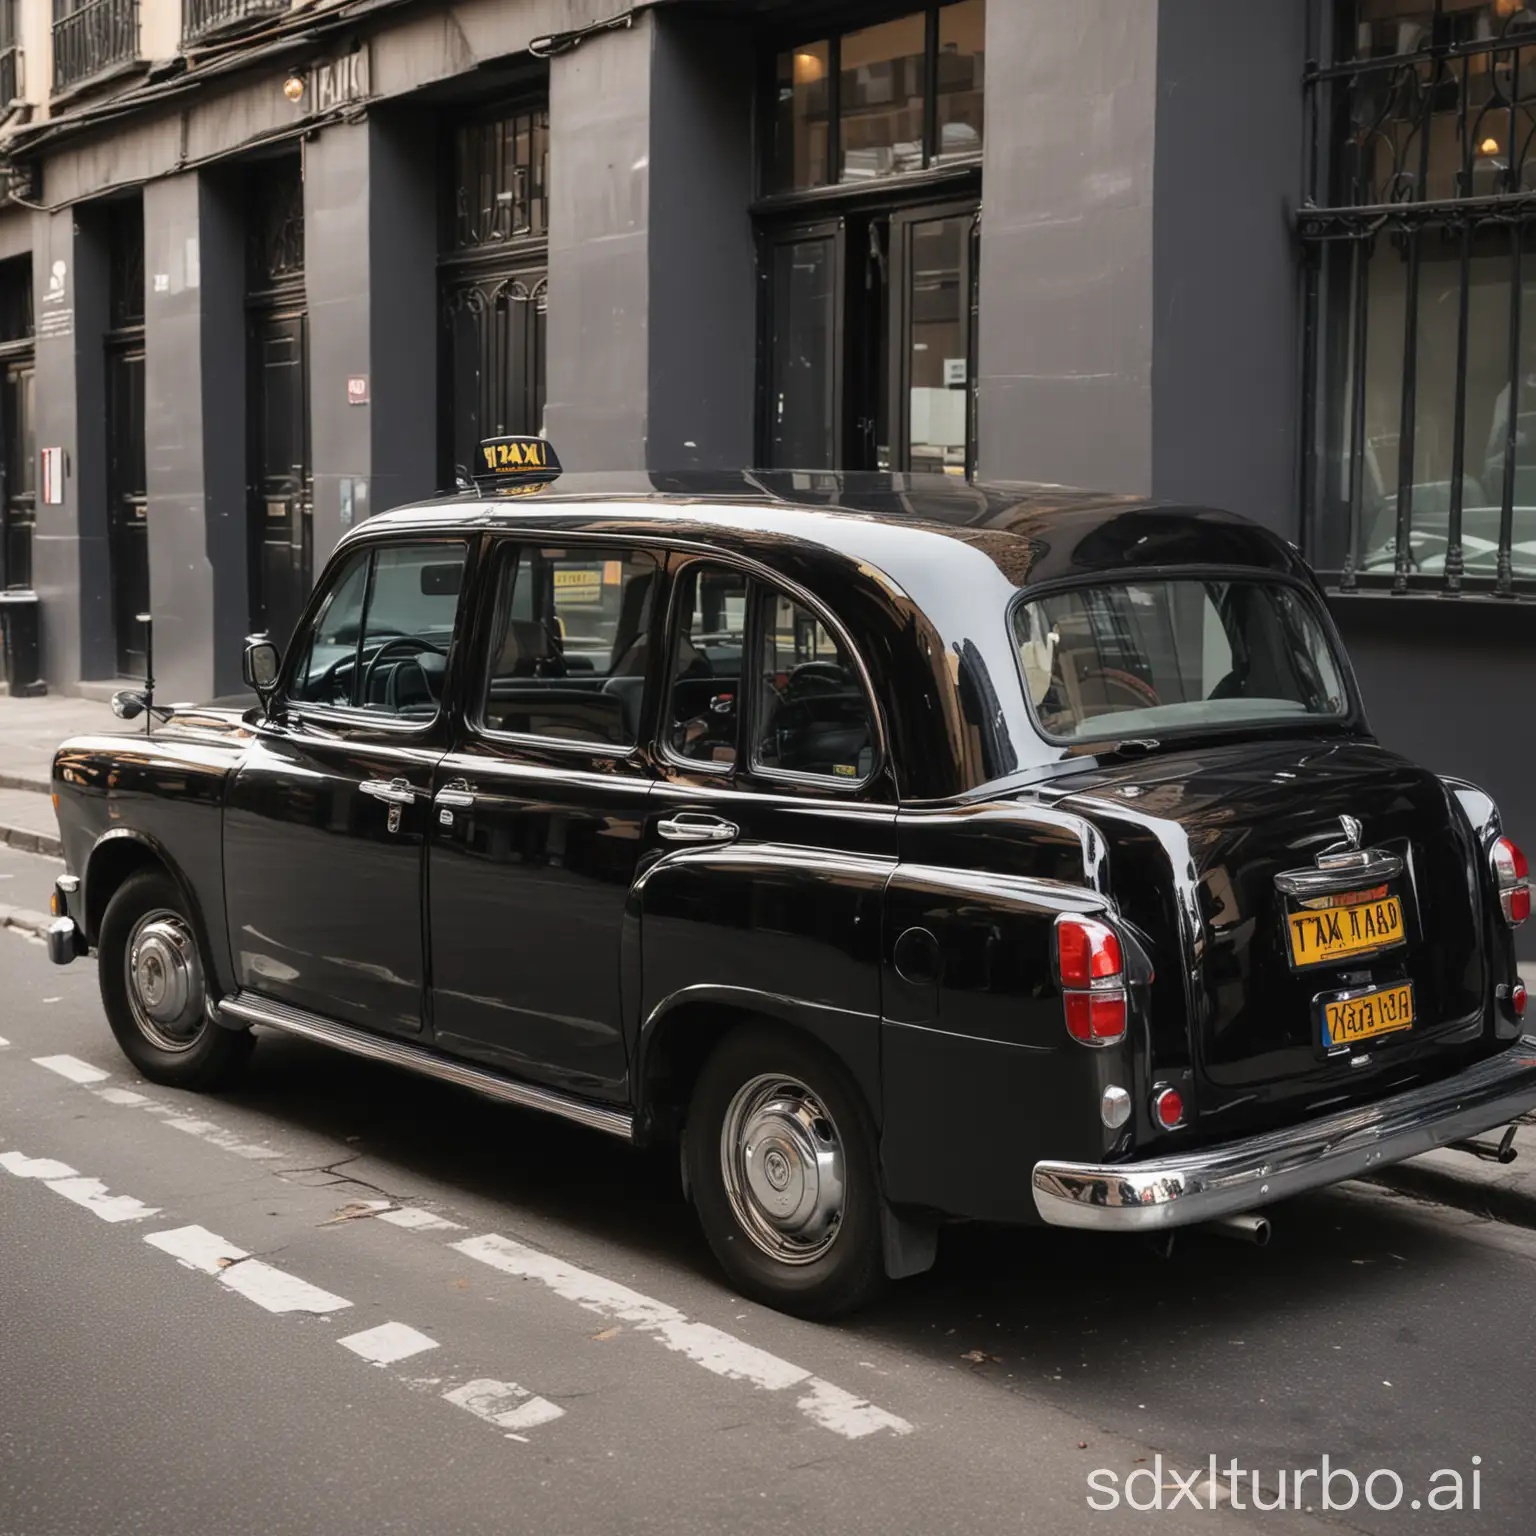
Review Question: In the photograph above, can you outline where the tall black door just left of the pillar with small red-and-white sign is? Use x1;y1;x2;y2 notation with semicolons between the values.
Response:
247;312;313;647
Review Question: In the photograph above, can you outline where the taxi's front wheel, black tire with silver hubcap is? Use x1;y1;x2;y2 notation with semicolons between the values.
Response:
97;869;255;1091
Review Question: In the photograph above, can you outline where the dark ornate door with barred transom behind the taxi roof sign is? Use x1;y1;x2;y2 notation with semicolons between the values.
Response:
438;103;550;484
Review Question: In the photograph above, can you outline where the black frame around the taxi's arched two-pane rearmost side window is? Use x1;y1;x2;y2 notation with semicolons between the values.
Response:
653;548;889;796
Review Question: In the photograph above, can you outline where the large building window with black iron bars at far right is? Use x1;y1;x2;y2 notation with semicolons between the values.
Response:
1299;0;1536;596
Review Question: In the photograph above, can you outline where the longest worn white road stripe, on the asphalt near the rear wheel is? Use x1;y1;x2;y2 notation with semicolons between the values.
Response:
452;1233;912;1439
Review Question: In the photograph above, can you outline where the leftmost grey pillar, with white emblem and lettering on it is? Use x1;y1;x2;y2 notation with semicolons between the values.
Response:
32;209;115;688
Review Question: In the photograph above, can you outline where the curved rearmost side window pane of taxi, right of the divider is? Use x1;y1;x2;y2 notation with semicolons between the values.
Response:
753;591;874;780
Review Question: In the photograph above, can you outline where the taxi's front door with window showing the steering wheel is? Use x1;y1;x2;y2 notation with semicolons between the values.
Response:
224;539;468;1035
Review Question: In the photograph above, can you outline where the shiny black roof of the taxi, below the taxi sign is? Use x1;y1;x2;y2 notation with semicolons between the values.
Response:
353;470;1306;587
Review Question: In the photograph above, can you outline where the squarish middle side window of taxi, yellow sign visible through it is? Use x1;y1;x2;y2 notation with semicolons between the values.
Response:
479;542;659;748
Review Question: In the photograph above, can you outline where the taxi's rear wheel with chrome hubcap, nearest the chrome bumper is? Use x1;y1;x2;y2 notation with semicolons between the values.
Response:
687;1028;885;1318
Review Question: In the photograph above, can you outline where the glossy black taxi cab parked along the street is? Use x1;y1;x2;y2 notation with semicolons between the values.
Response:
42;439;1536;1316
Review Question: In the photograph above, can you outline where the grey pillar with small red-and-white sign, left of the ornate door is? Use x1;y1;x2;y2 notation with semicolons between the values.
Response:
304;109;438;574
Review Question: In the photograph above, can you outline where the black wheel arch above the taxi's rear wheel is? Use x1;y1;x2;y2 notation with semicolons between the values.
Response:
634;983;882;1141
